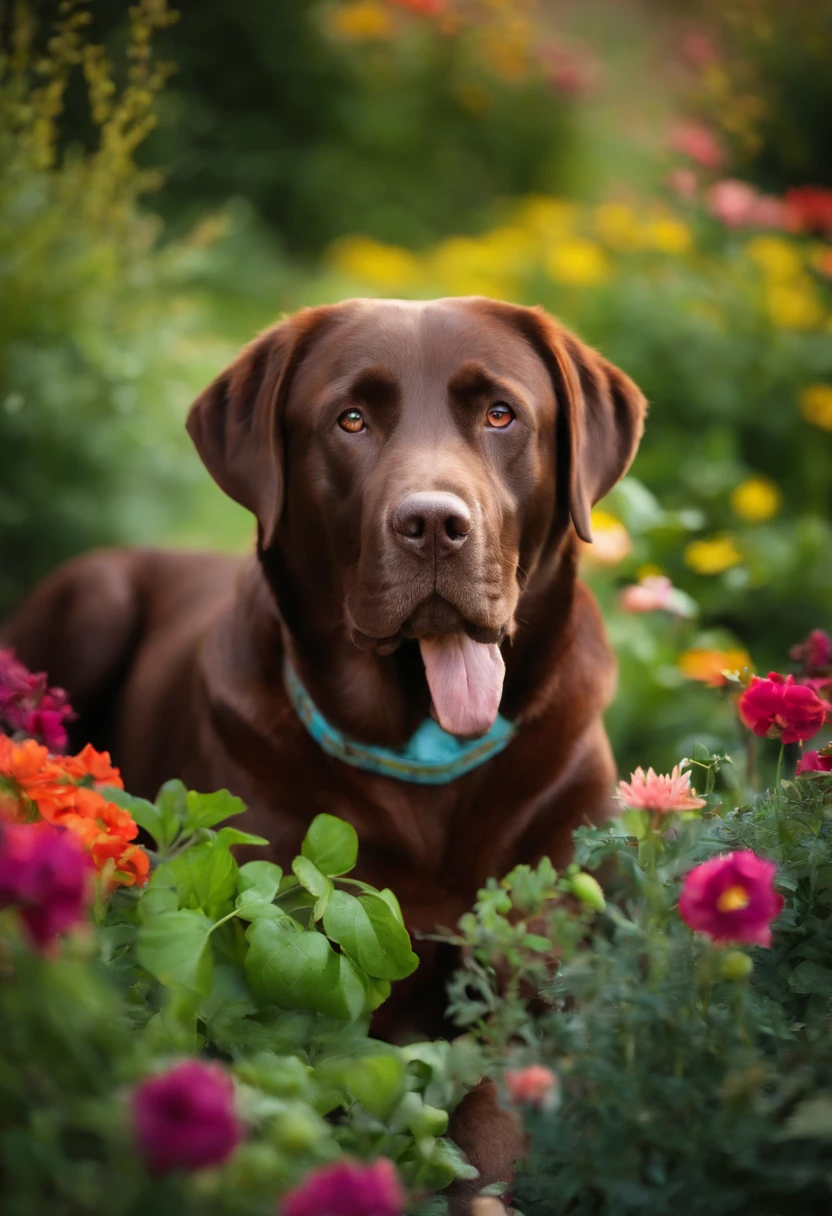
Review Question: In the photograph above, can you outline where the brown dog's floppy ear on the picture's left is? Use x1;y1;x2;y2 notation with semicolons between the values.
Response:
186;308;332;548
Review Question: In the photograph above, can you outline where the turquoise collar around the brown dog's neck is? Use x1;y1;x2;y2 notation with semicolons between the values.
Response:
289;663;517;786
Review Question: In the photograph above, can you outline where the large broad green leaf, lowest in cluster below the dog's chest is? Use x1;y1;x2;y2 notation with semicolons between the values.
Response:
246;916;366;1020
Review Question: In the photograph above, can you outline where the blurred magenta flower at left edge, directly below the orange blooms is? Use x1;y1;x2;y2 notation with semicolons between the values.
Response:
0;822;91;950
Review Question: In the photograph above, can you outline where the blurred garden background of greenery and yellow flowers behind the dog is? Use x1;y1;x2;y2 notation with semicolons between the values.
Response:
0;0;832;771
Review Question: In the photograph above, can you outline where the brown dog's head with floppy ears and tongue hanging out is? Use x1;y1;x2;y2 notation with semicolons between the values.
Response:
187;297;645;734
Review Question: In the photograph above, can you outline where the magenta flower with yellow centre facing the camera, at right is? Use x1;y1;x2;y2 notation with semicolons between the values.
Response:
679;849;783;946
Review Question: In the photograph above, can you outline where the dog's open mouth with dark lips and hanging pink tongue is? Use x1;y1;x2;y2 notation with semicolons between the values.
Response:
353;595;506;738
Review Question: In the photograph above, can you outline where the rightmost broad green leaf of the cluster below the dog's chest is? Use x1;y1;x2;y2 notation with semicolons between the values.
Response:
324;891;418;980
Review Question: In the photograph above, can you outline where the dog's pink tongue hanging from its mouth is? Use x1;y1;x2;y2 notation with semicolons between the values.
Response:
418;634;506;736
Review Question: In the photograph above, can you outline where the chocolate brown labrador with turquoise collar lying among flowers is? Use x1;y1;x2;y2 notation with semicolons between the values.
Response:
2;298;645;1196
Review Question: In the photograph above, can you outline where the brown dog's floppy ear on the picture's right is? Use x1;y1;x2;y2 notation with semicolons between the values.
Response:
493;308;647;541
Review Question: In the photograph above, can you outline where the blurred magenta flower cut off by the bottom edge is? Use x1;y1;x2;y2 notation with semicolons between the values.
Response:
280;1156;405;1216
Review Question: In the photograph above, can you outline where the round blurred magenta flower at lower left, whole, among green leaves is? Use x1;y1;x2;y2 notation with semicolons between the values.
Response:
133;1060;242;1173
